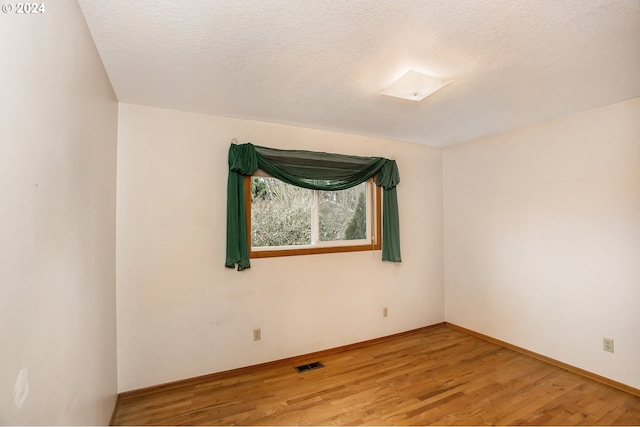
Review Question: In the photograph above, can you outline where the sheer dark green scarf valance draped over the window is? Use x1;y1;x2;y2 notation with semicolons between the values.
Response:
225;143;401;271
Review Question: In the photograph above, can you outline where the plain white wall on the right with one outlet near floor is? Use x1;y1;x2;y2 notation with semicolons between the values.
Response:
444;98;640;388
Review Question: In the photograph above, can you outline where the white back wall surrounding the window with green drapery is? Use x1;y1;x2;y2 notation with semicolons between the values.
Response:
117;104;444;391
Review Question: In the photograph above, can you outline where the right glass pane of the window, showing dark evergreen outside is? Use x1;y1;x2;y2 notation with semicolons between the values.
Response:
318;182;367;242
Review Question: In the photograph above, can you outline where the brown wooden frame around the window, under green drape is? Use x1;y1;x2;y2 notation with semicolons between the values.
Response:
244;175;382;258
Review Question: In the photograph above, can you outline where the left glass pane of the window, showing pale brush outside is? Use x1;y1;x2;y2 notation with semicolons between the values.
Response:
251;177;311;247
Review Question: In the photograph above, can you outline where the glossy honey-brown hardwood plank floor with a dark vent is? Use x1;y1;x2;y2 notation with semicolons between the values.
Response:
113;326;640;425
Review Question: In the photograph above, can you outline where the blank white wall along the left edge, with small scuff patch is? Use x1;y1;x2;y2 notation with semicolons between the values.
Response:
0;1;118;425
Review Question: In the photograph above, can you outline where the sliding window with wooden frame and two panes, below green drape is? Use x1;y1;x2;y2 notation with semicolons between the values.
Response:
245;175;380;258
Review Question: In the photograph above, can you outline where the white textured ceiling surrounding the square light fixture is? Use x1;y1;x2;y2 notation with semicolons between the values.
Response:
79;0;640;146
